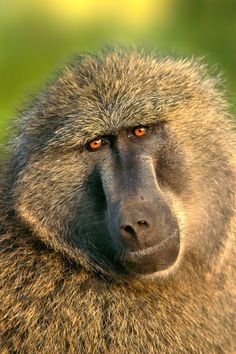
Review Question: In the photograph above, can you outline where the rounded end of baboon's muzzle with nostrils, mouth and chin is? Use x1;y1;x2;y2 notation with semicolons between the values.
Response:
117;199;180;274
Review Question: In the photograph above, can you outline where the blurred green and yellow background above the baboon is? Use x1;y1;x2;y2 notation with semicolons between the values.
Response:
0;0;236;143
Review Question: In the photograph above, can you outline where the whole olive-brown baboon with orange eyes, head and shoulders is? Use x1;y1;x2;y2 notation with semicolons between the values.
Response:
0;50;236;354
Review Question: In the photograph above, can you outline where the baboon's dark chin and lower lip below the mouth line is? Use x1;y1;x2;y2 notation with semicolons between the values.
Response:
122;235;180;276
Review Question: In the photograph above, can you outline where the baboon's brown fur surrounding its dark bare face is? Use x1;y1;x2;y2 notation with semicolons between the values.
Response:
0;52;236;354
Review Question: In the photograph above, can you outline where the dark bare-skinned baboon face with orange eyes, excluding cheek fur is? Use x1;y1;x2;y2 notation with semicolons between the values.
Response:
79;123;179;274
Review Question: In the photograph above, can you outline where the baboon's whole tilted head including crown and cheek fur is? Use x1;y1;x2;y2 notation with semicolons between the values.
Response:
14;52;232;276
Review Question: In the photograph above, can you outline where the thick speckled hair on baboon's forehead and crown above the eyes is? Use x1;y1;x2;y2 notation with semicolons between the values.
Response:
18;51;223;149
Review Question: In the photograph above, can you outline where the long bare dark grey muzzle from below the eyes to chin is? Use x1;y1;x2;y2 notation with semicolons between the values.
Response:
100;142;180;274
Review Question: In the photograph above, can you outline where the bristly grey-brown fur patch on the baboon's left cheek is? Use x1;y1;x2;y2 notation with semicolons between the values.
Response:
14;153;89;235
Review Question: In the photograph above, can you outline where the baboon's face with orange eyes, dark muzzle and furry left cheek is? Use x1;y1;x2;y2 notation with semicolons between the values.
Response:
15;116;187;275
